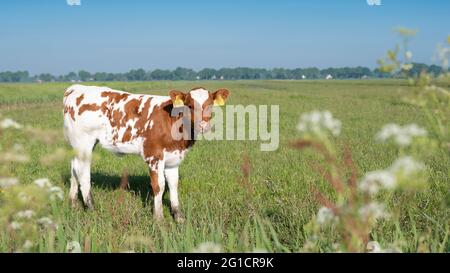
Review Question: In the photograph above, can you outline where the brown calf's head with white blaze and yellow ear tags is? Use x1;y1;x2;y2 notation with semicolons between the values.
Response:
169;87;230;133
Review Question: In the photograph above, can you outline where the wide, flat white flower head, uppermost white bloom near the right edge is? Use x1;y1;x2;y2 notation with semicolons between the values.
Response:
375;123;427;147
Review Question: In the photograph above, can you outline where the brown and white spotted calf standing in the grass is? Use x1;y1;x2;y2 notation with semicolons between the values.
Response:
64;85;229;221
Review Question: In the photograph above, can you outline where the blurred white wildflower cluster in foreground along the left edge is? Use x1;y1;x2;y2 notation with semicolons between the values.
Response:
0;115;64;252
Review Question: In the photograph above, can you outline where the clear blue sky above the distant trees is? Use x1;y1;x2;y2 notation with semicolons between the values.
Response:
0;0;450;74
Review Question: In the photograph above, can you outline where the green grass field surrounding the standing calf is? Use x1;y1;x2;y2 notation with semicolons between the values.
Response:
0;80;450;252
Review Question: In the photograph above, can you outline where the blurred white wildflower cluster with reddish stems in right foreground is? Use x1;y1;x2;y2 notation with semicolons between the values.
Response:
294;112;427;252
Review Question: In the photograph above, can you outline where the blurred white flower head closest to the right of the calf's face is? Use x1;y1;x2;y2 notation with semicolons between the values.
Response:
297;111;341;136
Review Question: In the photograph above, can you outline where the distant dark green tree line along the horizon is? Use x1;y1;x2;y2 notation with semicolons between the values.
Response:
0;63;443;82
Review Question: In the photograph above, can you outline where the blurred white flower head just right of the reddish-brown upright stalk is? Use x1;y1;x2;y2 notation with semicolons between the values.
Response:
359;170;396;195
